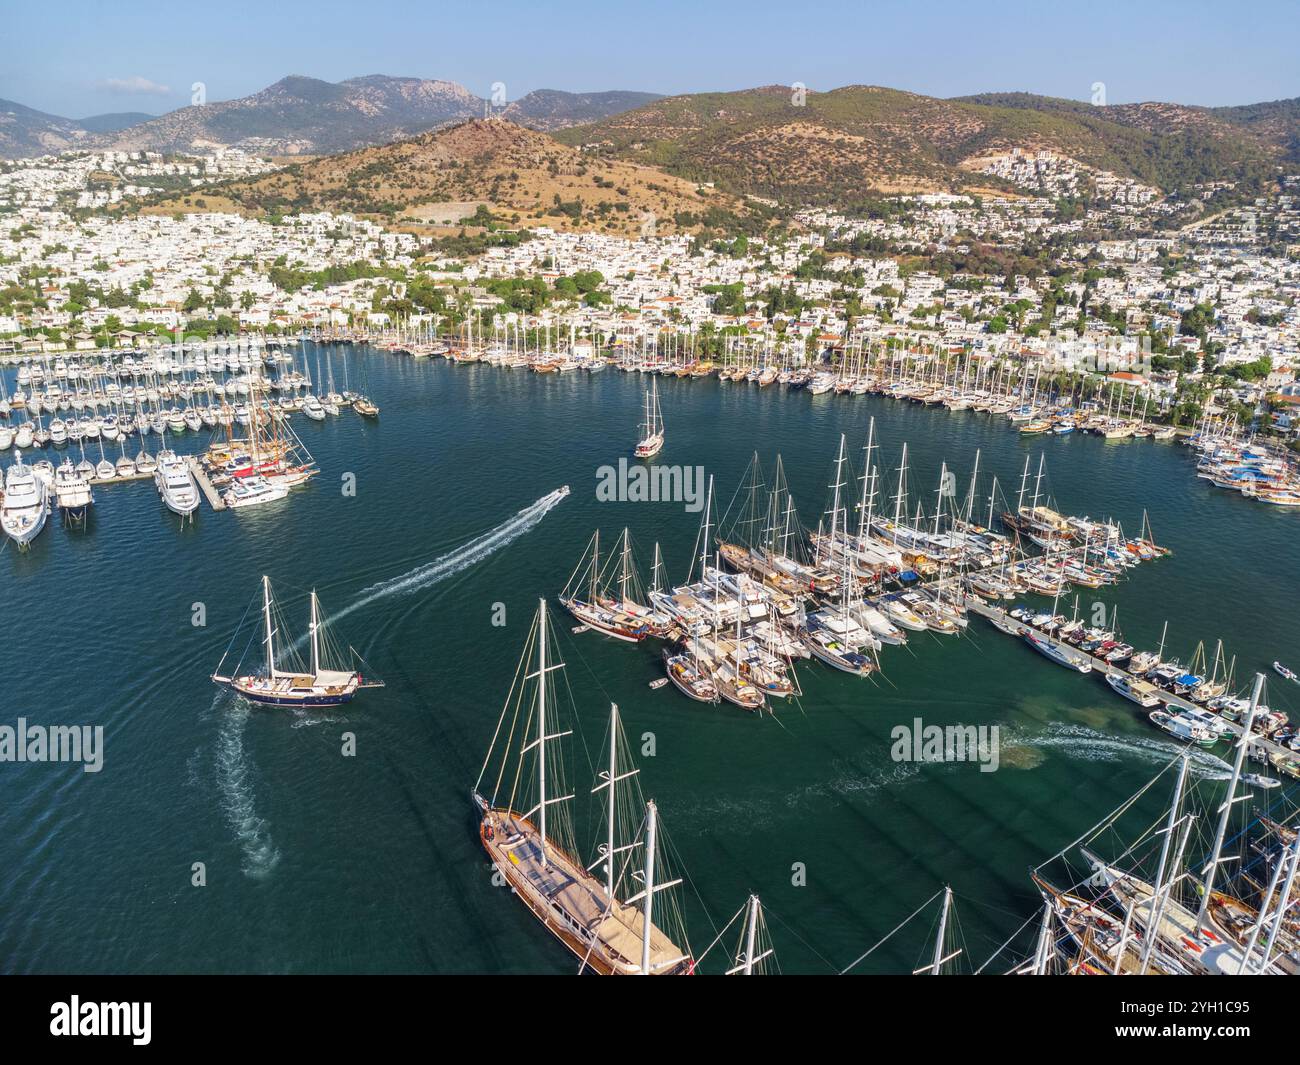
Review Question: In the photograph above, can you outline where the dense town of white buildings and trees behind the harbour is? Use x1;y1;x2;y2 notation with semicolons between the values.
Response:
0;150;1300;434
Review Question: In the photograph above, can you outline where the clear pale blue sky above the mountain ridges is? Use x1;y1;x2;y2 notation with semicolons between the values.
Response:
0;0;1300;117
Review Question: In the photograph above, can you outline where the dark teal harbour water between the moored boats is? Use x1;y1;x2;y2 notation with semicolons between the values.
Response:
0;346;1300;973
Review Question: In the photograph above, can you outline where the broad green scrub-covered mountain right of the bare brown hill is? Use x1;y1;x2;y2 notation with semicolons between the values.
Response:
556;86;1281;203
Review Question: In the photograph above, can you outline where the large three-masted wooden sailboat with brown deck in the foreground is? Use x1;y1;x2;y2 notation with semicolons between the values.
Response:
472;599;696;975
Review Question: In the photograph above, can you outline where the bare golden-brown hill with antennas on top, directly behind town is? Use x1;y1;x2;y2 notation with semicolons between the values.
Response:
182;118;744;234
